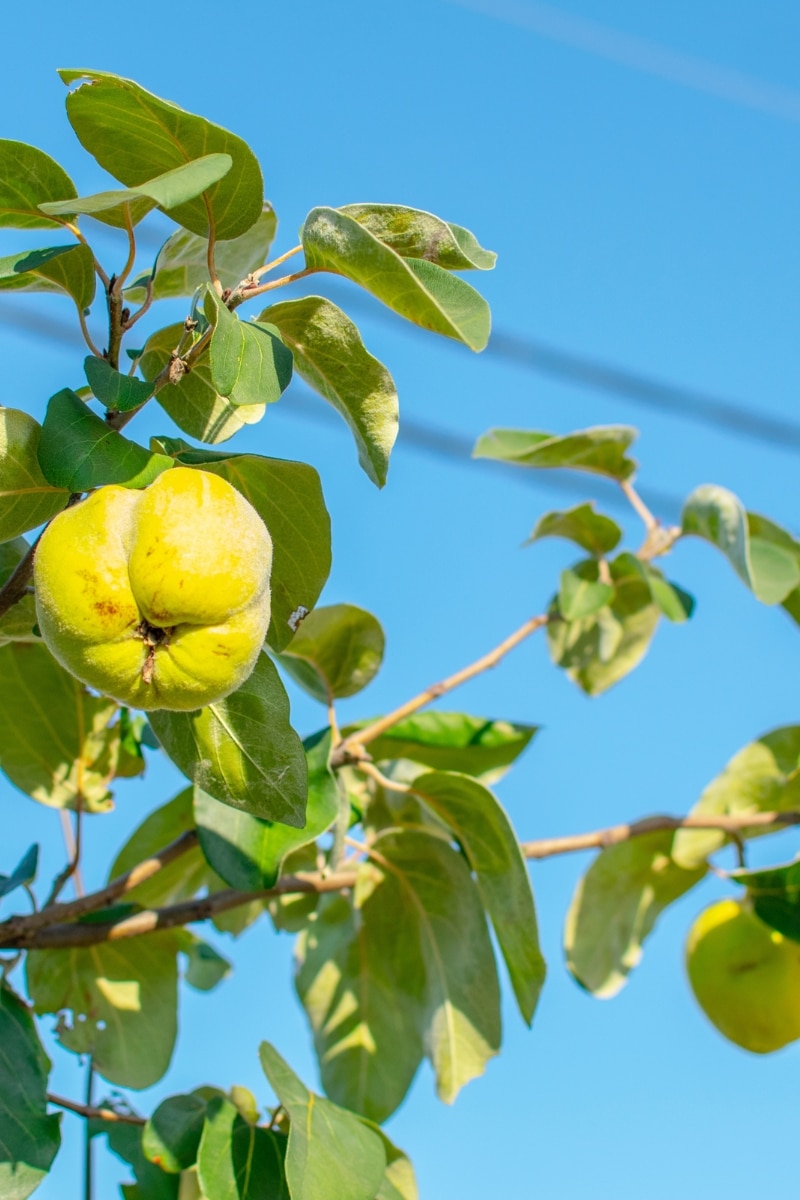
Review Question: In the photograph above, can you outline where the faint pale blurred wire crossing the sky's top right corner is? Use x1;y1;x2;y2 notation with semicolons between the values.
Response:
446;0;800;122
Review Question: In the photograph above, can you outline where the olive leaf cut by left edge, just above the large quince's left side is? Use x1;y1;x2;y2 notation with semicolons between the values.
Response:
0;408;70;542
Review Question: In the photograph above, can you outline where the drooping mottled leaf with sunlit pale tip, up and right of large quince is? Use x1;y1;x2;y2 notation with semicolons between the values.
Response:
259;296;398;487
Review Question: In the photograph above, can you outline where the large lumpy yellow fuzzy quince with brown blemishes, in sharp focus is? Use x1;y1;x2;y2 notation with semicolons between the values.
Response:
34;467;272;712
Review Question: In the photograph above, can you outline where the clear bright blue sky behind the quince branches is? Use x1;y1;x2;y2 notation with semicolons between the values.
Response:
0;0;800;1200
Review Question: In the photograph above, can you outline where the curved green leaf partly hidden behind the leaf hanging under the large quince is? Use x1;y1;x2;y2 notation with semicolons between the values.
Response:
194;731;338;892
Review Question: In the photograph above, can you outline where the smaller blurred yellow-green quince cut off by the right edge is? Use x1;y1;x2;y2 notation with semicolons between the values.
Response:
686;900;800;1054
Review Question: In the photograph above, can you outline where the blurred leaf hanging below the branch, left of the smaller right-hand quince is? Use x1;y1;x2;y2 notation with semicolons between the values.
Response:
564;833;705;997
